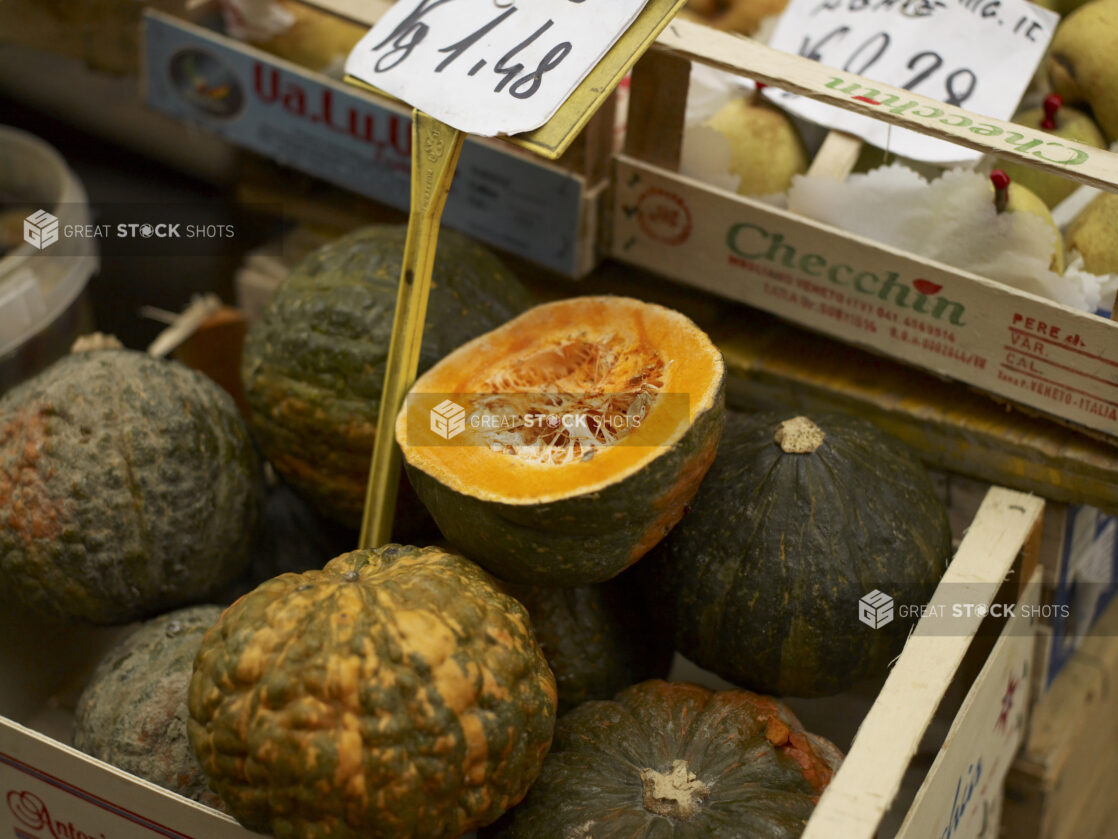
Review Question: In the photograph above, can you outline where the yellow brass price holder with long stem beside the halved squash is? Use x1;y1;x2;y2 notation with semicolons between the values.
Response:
345;0;686;548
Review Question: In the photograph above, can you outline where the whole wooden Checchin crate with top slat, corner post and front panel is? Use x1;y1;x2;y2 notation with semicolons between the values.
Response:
609;20;1118;441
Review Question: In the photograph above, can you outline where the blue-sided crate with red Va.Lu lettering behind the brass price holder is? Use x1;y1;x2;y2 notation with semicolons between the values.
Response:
143;2;614;276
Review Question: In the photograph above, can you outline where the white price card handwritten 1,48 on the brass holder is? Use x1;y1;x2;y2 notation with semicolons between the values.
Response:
345;0;647;136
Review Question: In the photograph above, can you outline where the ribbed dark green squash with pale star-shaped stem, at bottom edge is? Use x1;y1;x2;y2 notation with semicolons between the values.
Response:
481;680;842;839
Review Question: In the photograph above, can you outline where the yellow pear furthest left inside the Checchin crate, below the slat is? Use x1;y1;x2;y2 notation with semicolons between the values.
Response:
703;91;808;196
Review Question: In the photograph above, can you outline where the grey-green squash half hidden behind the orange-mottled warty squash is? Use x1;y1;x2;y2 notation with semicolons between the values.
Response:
74;605;222;810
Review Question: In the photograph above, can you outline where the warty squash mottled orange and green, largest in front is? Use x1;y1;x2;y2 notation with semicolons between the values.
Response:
188;545;556;839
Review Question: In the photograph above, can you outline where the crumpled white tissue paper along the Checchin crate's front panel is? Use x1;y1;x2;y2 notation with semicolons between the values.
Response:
788;164;1112;312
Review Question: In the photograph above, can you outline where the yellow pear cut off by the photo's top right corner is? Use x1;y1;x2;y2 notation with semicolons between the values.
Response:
1045;0;1118;142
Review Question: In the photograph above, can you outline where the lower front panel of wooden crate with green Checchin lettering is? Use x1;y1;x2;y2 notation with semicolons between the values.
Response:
612;157;1118;436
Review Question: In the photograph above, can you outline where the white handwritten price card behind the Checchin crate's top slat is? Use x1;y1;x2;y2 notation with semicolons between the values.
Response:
766;0;1060;163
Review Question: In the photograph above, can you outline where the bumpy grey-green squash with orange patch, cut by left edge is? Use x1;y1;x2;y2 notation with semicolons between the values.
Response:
0;349;263;624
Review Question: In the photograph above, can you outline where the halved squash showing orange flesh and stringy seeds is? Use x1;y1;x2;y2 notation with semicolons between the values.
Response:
396;296;724;586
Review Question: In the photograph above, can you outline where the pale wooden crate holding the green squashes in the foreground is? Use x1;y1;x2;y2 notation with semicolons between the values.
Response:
0;489;1043;839
